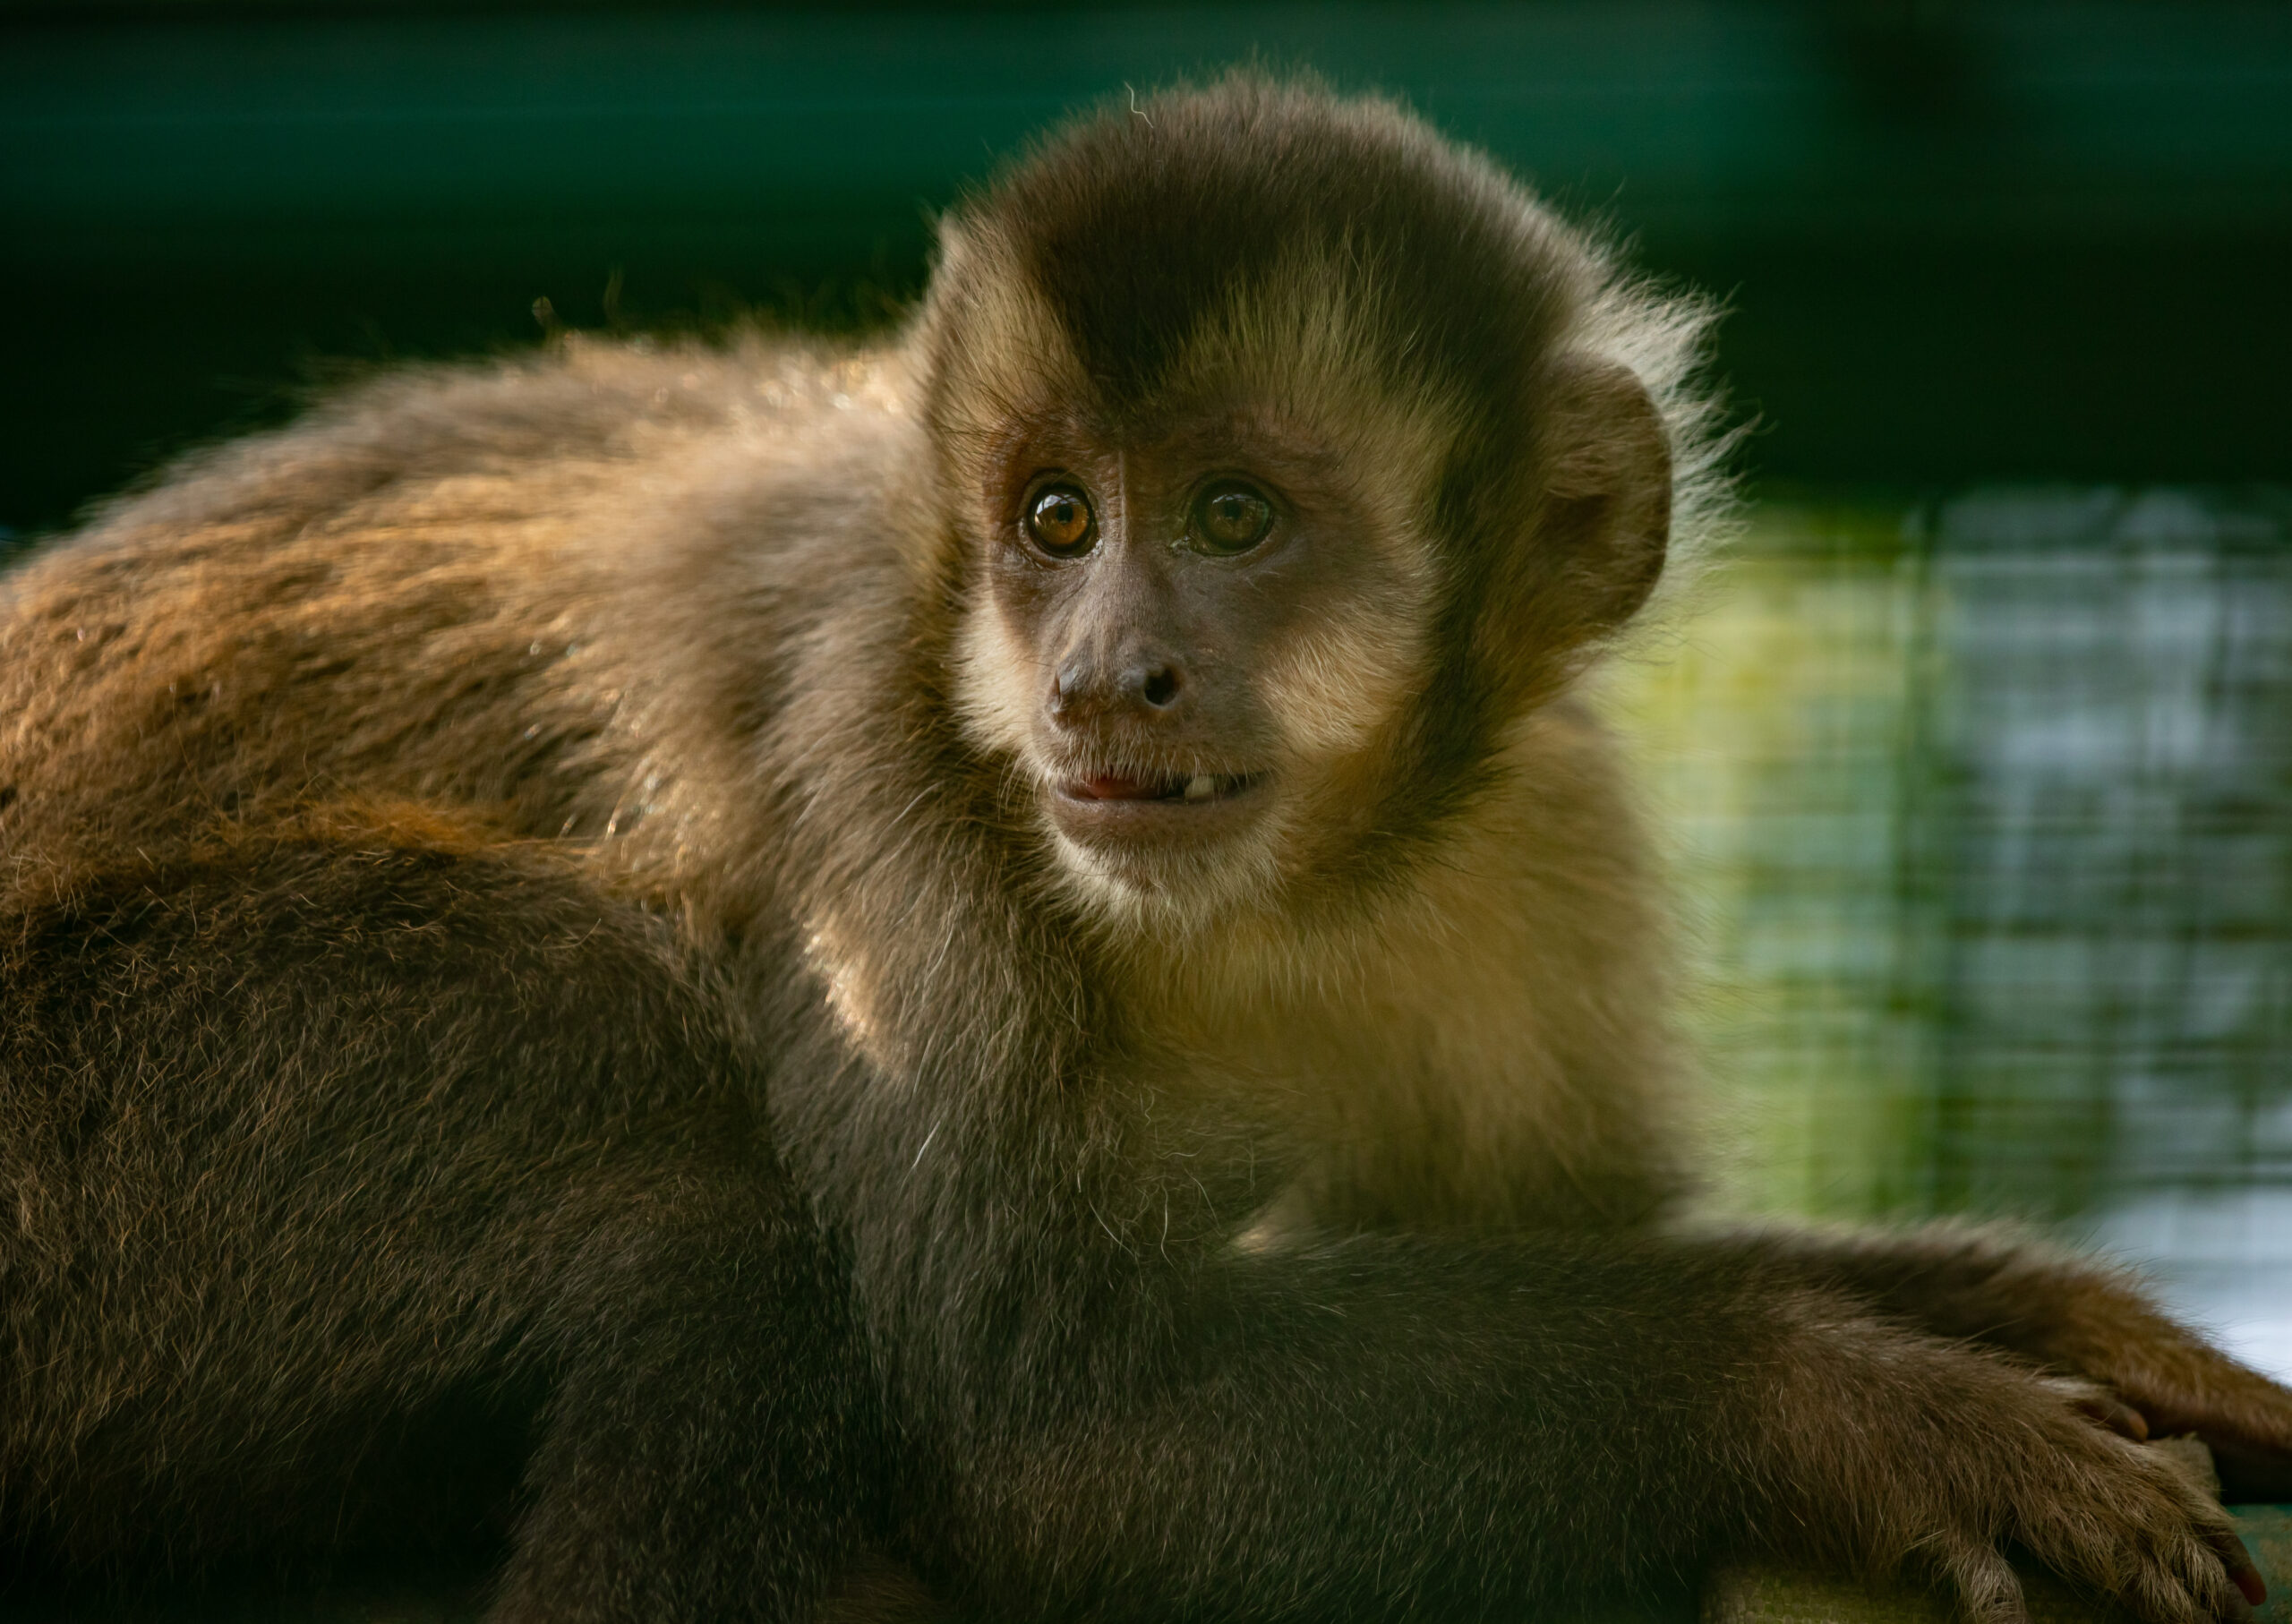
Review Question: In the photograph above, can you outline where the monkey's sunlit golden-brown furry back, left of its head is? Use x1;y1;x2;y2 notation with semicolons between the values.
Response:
0;339;903;888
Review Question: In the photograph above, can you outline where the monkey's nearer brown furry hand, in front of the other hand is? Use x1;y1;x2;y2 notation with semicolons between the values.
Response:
1753;1303;2264;1624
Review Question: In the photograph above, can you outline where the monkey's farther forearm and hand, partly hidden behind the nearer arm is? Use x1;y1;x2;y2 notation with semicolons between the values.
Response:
1728;1223;2292;1500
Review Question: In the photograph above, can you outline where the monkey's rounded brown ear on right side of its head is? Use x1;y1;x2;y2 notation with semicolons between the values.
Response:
1538;350;1671;637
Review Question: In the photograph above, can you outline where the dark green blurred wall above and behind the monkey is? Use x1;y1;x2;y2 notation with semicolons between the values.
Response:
0;0;2292;529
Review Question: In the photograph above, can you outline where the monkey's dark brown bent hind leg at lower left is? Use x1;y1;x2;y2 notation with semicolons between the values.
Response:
0;829;867;1624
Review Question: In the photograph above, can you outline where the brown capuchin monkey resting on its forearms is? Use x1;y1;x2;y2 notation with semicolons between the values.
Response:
0;75;2292;1624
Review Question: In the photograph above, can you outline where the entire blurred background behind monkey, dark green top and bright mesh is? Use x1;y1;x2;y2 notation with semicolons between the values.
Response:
0;0;2292;1372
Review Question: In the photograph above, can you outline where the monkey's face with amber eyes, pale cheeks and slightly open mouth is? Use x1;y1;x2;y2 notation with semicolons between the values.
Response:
961;403;1435;923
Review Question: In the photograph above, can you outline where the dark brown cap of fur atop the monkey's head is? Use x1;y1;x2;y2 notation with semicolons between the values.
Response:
930;73;1597;446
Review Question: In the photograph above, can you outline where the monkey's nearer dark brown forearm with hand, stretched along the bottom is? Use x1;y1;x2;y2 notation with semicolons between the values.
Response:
894;1237;2242;1621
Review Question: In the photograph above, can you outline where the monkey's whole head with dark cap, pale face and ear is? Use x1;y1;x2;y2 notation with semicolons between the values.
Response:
917;75;1687;927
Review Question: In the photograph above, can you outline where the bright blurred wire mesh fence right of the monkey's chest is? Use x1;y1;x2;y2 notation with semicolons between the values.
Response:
1612;491;2292;1370
